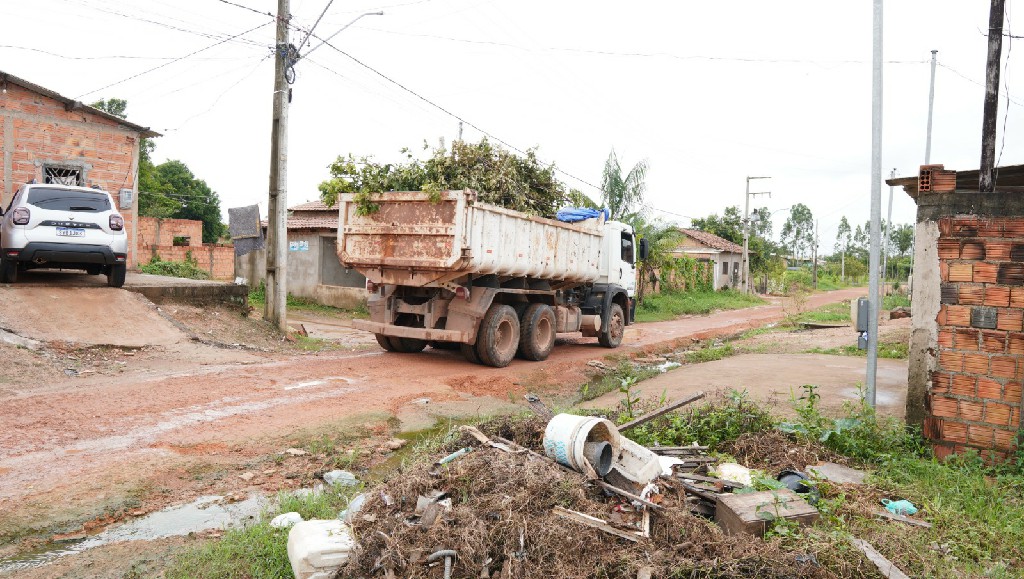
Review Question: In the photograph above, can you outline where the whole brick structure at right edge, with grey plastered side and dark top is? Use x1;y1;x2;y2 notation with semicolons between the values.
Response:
887;165;1024;459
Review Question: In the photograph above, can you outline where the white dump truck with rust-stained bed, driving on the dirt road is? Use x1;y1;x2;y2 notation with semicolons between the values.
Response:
337;190;646;368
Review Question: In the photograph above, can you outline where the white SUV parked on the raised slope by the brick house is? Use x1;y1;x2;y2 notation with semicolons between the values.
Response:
0;183;128;288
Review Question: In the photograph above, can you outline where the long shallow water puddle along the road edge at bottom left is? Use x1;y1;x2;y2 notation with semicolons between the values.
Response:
0;495;271;573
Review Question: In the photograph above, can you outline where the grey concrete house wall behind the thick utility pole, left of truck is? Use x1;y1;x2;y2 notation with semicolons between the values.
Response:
234;230;367;308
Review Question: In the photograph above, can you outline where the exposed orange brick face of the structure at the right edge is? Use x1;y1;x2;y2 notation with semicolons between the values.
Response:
915;215;1024;457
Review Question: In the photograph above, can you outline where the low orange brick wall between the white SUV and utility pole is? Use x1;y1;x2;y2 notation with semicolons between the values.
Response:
138;217;234;280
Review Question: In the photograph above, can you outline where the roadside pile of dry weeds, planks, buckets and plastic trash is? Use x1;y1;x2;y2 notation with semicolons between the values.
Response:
289;399;929;579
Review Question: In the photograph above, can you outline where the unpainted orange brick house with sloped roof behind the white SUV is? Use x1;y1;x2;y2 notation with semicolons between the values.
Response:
0;71;160;267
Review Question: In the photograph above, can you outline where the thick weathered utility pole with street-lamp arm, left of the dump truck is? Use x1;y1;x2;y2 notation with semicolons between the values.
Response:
263;0;295;331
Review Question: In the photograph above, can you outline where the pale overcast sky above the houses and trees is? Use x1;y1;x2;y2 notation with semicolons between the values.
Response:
0;0;1024;252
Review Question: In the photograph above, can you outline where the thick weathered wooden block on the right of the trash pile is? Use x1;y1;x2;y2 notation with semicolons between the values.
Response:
715;489;818;537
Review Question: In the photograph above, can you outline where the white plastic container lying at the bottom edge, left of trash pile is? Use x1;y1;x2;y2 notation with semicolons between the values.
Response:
288;519;355;579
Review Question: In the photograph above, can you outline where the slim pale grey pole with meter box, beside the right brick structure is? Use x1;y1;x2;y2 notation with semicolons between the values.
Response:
864;0;882;408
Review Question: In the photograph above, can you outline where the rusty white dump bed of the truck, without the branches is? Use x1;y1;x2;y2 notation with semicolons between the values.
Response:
338;190;603;286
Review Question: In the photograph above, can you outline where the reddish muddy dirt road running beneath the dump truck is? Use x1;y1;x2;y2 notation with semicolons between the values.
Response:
0;289;864;545
